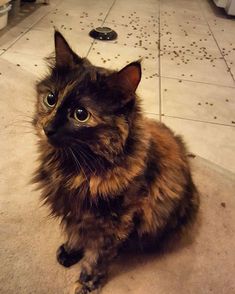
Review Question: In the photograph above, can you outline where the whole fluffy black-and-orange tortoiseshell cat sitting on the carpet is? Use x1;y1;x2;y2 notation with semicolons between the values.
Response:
34;31;199;294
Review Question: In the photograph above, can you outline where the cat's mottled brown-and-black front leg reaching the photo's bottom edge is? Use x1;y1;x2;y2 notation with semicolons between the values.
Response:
74;244;117;294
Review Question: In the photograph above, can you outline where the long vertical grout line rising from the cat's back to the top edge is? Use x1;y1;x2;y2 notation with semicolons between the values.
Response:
158;0;162;121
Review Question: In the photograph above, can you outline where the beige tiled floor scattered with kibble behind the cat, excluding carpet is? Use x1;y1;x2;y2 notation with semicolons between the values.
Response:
0;0;235;172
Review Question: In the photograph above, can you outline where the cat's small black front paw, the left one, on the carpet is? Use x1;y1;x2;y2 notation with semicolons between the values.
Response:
56;244;83;267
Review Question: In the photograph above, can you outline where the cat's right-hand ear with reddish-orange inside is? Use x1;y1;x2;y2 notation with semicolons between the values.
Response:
118;61;141;93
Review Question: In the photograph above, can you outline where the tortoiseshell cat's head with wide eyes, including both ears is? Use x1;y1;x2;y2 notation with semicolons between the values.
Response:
34;32;141;163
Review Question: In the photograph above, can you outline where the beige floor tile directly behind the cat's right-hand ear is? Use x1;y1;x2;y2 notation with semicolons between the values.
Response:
88;42;159;113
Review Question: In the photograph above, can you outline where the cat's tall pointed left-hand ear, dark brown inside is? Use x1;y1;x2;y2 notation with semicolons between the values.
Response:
54;31;82;68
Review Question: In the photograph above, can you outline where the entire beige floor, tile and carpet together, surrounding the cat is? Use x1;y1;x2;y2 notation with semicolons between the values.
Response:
0;0;235;294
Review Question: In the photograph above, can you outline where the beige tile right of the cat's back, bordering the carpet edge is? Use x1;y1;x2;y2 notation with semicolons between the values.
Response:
162;116;235;173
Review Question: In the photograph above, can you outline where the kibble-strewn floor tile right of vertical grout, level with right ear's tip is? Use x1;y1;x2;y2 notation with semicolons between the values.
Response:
161;51;235;87
